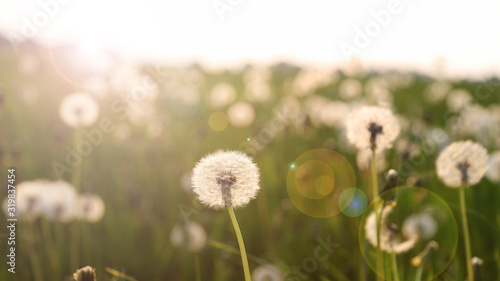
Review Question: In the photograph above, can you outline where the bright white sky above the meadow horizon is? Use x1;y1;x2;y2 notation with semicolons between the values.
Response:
0;0;500;77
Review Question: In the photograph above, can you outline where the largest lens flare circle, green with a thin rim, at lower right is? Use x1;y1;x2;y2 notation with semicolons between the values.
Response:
359;187;458;280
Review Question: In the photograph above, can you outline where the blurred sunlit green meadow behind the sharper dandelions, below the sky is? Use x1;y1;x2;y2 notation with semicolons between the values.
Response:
0;44;500;281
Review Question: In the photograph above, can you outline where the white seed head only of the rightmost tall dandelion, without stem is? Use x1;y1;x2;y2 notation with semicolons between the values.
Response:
436;140;488;187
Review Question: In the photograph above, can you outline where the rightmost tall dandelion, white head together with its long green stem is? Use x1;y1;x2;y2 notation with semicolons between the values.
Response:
436;140;488;281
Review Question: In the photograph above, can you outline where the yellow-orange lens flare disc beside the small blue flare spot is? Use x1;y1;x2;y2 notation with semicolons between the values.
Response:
287;149;356;218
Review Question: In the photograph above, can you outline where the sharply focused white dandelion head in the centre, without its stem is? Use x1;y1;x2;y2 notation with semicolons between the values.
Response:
192;151;260;209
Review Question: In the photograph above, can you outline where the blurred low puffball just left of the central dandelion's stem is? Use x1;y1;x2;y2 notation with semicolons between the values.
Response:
170;222;207;252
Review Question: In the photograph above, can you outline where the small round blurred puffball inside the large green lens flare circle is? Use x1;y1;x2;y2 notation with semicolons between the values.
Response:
403;212;438;240
